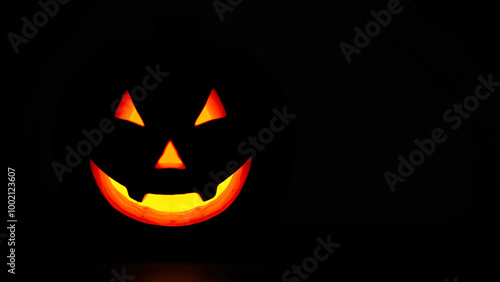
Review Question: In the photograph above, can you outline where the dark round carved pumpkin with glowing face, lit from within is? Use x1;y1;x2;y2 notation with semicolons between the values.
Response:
54;30;294;241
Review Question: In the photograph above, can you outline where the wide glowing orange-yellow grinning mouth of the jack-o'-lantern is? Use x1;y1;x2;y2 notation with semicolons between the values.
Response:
90;158;252;226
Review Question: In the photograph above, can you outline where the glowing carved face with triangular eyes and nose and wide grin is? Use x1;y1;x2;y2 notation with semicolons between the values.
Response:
90;86;251;226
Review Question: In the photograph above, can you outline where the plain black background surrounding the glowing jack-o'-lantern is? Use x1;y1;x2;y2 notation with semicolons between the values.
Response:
1;1;500;281
